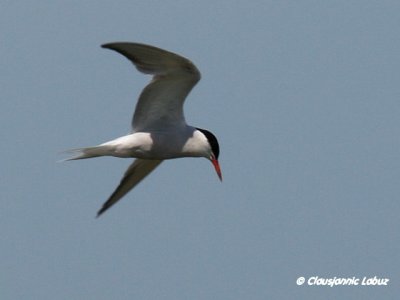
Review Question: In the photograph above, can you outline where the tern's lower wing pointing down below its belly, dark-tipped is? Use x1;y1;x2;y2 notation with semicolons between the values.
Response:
97;158;162;217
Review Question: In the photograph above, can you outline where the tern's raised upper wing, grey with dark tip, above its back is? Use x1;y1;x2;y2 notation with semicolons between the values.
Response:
102;43;200;131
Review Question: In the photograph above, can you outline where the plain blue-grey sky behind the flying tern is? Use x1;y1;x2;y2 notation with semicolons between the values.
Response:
0;0;400;299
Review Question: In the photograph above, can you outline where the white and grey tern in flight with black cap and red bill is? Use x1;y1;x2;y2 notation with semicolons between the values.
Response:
66;42;222;217
